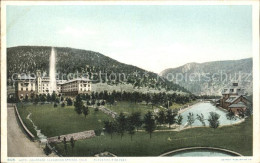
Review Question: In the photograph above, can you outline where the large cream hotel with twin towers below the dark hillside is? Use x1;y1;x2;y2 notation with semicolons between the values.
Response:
15;71;91;99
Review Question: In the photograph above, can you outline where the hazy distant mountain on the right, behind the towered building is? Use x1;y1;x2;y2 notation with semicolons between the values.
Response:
160;58;253;95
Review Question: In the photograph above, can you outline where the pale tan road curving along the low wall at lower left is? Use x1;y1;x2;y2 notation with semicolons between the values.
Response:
7;107;46;157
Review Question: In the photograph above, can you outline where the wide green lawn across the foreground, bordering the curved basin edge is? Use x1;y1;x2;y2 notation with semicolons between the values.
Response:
55;118;253;156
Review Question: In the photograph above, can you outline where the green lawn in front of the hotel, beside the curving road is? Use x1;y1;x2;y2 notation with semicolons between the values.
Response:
18;104;111;137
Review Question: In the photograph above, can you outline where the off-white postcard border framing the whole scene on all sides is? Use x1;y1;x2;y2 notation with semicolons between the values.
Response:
1;1;260;163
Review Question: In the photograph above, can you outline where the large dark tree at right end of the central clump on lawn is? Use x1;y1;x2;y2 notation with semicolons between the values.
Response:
144;111;156;139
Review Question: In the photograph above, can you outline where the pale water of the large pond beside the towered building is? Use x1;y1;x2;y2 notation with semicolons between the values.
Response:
181;102;242;127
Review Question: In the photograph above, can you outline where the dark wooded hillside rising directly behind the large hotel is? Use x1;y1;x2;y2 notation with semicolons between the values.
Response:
7;46;190;93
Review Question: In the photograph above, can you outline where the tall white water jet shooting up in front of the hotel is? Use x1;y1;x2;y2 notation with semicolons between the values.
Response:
49;48;56;93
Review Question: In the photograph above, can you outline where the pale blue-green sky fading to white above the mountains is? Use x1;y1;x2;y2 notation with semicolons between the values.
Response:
6;5;252;73
